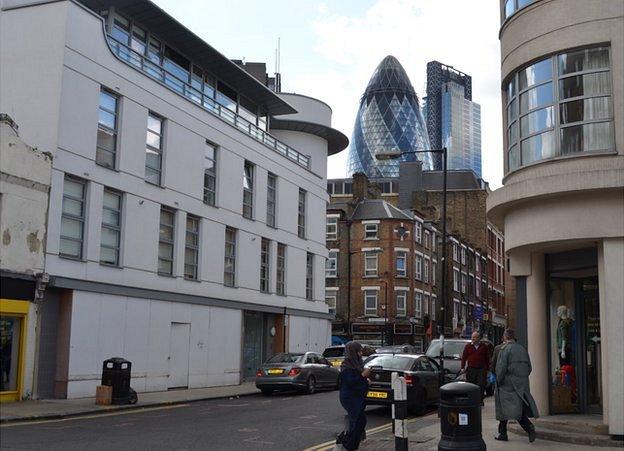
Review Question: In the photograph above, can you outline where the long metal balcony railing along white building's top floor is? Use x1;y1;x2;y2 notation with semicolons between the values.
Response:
108;35;310;169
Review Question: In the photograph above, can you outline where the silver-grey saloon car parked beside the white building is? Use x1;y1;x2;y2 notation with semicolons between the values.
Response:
256;352;340;395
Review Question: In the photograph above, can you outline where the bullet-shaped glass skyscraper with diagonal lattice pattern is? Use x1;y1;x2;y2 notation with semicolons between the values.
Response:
348;56;433;177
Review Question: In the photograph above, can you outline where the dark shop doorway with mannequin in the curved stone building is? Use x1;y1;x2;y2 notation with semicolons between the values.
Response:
547;249;602;414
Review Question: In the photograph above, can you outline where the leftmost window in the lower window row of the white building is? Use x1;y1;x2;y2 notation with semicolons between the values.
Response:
59;175;87;259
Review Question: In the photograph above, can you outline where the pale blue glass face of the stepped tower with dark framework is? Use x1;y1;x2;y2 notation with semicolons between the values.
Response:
441;82;481;177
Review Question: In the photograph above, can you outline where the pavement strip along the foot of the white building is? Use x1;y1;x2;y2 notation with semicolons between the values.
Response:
0;382;259;423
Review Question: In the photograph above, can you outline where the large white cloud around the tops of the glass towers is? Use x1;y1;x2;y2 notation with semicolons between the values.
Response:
289;0;503;187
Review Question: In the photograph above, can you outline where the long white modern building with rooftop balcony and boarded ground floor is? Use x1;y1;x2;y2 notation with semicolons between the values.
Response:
0;0;348;398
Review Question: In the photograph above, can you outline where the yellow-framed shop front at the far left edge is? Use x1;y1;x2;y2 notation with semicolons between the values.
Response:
0;299;30;402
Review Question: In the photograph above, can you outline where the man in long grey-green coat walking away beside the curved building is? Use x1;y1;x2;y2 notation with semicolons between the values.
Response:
494;329;539;443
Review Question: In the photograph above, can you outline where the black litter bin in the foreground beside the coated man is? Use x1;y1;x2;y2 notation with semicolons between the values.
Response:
438;382;486;451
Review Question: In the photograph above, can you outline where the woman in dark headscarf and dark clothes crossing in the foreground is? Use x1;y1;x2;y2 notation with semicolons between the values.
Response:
336;341;370;451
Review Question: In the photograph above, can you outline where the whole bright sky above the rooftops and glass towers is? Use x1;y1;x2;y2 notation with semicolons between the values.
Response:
154;0;503;188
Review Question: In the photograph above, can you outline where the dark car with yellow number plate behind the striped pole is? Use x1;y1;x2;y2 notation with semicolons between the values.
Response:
364;354;440;415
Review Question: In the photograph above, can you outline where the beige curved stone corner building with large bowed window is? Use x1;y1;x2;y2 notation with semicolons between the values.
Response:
487;0;624;437
